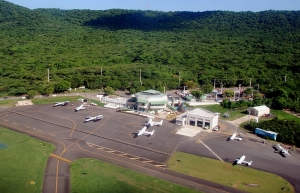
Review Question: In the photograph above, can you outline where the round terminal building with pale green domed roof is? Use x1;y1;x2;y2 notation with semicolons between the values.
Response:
135;90;168;112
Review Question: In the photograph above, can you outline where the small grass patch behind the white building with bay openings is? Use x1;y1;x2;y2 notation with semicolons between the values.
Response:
194;105;247;121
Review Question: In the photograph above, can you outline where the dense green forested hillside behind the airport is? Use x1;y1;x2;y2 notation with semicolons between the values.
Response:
0;1;300;109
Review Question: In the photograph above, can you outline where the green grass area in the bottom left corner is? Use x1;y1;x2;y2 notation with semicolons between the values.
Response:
0;127;54;193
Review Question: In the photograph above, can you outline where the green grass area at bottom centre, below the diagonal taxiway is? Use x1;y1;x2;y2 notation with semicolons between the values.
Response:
71;159;198;193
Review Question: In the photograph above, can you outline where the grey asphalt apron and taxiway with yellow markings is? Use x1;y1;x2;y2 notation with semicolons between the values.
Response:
0;103;300;192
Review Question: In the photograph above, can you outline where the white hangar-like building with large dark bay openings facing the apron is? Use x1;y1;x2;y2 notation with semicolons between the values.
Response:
176;108;219;129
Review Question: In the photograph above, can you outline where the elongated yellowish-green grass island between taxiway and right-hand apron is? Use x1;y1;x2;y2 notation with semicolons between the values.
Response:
168;152;294;193
